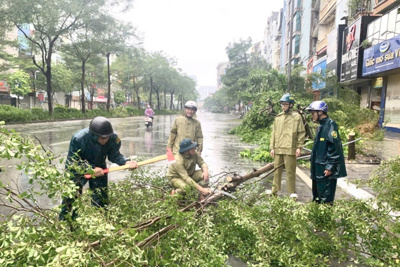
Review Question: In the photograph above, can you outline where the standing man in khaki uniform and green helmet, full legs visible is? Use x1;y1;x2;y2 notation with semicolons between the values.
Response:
270;94;305;198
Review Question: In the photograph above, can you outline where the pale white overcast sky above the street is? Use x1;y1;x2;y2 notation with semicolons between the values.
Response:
126;0;283;86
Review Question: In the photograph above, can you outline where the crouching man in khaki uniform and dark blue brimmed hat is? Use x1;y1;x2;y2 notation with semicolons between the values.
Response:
167;138;210;195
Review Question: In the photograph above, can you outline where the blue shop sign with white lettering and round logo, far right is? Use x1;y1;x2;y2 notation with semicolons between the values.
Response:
362;35;400;77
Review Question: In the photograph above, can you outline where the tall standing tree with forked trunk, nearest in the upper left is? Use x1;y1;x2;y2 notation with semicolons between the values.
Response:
0;0;132;115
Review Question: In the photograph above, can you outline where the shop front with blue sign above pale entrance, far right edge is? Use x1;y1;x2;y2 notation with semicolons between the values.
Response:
361;1;400;132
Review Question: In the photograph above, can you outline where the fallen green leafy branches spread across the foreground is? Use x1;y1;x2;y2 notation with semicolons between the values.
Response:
0;129;400;266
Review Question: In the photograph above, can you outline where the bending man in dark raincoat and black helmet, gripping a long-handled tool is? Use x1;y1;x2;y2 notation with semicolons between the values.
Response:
60;117;137;220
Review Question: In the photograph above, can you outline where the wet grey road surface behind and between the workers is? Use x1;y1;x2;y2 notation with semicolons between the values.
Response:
0;112;348;210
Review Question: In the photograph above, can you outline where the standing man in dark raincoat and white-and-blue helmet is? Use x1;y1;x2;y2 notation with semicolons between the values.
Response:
307;101;347;205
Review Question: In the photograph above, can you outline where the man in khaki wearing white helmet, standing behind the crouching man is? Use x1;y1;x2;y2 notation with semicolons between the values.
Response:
167;101;203;155
